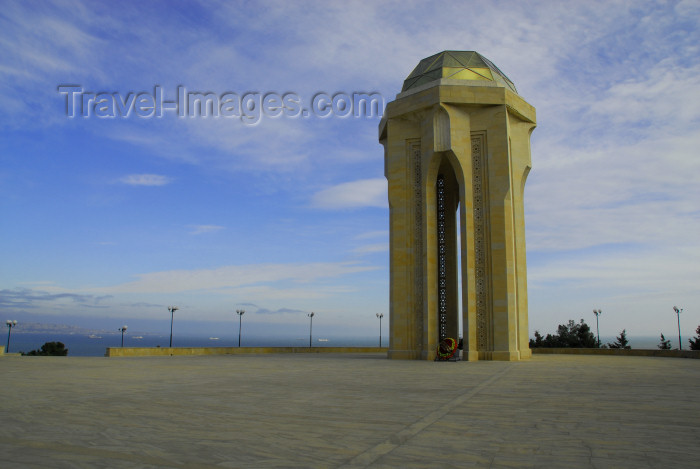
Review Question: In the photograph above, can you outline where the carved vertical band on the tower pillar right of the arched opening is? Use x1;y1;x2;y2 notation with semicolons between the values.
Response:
471;133;490;350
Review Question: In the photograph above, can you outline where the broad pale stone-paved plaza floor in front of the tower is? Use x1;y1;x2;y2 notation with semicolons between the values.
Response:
0;354;700;469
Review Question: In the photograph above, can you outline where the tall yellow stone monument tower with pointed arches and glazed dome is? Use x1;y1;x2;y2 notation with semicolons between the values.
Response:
379;51;536;360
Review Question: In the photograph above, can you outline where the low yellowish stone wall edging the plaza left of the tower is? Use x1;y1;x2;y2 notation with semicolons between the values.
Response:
105;347;387;357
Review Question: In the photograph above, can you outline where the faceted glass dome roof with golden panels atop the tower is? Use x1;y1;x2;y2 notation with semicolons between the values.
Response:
401;50;518;93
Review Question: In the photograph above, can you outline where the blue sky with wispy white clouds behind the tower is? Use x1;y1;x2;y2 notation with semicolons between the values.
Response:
0;0;700;337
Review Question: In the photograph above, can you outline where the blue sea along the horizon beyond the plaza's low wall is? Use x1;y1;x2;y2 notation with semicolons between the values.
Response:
4;332;672;357
